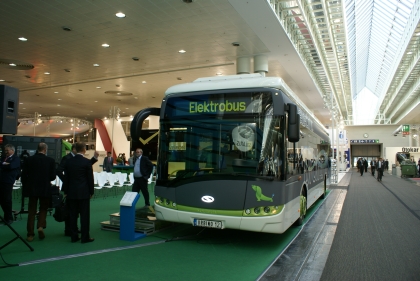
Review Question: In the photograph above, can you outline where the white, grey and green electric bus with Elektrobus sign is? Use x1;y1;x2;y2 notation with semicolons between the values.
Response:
131;74;329;233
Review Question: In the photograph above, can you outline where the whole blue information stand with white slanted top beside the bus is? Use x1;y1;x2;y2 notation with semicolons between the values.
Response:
120;191;146;241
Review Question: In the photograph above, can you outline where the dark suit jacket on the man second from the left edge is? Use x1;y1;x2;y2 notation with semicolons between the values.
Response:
22;153;55;197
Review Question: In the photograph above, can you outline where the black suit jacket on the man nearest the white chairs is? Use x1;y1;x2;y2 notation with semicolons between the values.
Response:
62;154;94;199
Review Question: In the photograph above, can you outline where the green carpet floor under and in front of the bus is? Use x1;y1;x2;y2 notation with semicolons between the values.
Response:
0;185;322;281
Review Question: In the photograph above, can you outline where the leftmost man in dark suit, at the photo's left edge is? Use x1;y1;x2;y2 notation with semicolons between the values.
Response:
0;144;20;224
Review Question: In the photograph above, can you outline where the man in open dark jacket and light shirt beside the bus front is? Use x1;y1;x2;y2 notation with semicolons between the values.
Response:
131;148;153;207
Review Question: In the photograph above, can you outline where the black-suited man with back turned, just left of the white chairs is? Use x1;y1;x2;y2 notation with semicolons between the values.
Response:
62;142;95;243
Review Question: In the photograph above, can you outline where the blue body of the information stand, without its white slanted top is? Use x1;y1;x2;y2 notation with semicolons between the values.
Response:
120;194;146;241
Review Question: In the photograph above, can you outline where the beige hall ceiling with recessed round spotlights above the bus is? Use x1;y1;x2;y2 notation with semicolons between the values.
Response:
0;0;420;136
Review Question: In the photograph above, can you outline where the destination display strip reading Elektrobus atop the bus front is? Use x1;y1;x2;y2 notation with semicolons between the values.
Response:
165;92;271;117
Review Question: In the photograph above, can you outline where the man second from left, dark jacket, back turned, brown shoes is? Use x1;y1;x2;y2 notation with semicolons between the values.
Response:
22;142;55;242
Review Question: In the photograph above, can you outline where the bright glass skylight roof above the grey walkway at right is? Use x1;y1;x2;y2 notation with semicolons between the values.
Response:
344;0;416;124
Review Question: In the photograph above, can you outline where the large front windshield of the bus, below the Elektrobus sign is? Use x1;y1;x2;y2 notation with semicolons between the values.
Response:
159;90;284;180
